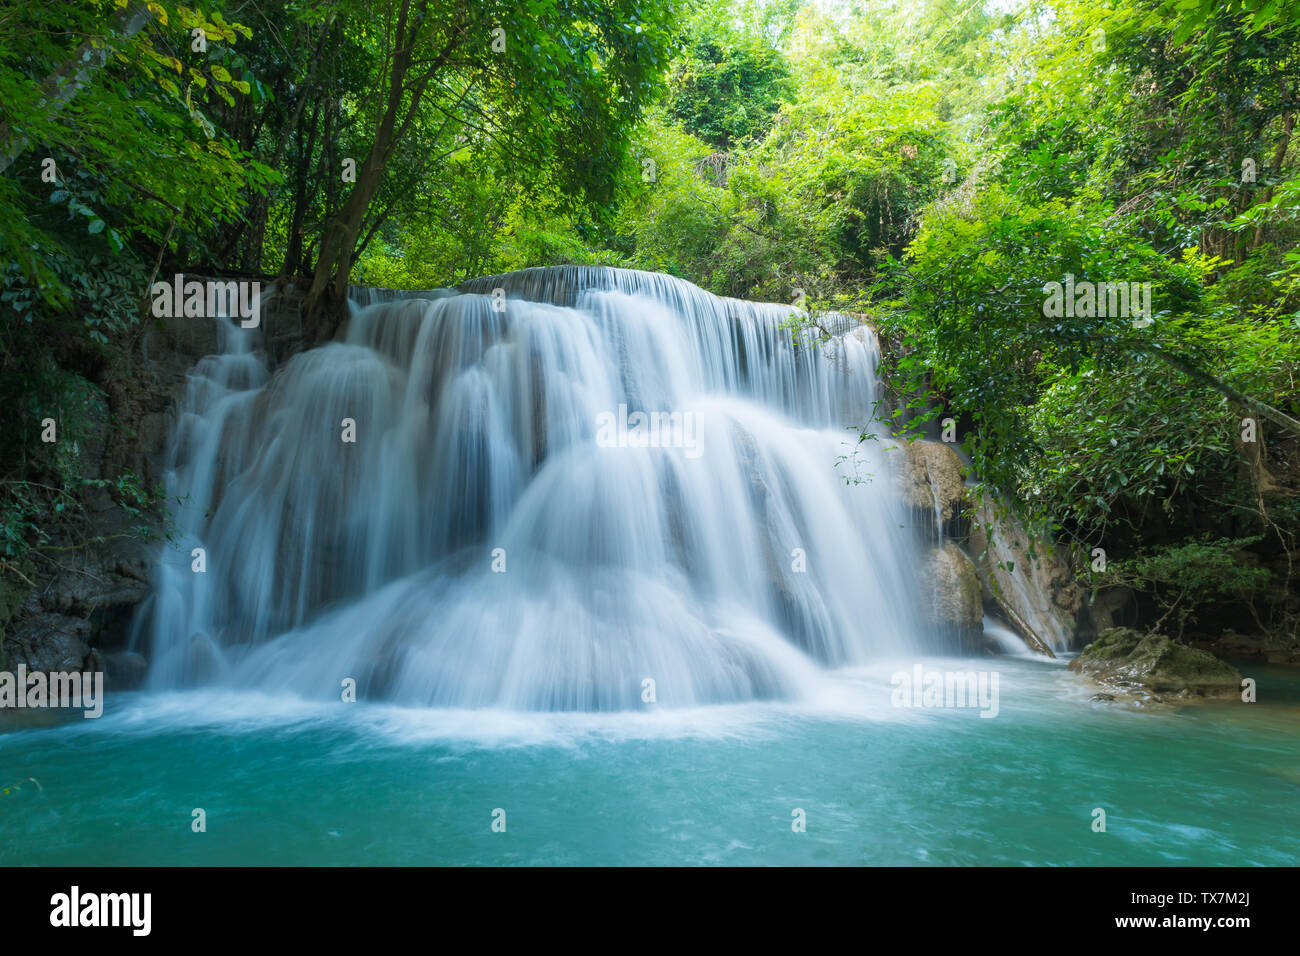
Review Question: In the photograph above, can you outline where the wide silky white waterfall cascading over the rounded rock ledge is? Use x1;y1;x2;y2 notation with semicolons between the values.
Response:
137;267;927;710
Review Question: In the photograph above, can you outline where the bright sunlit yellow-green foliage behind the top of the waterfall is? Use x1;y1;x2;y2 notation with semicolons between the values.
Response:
614;5;966;308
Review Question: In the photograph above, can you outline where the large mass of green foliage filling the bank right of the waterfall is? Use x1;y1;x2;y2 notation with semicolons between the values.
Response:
880;3;1300;582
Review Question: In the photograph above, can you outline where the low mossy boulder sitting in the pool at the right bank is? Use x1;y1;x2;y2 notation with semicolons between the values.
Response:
1070;627;1242;700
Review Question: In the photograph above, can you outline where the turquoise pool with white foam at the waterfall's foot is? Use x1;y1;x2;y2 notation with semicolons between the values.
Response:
0;658;1300;866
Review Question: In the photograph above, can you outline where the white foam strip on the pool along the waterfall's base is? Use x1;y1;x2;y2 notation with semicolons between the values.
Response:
30;656;1083;749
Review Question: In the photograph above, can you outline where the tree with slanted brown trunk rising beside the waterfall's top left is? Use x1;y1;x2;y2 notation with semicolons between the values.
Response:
297;0;672;338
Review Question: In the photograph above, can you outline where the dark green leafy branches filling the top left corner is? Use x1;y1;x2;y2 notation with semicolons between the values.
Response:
0;0;270;311
